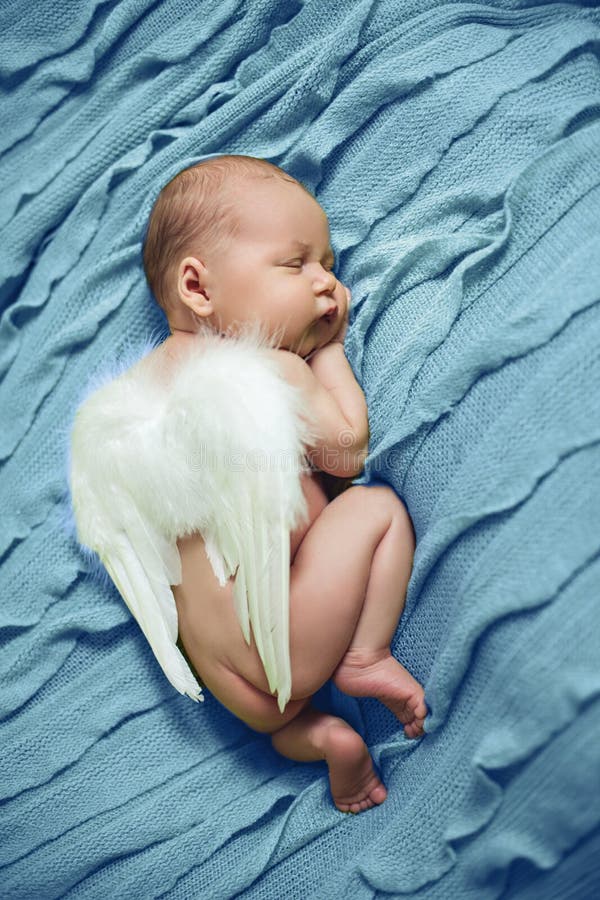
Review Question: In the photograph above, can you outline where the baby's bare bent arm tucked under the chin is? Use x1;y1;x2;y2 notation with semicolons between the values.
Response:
273;341;369;478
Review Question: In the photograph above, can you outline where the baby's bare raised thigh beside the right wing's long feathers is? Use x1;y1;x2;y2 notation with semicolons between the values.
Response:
290;485;402;699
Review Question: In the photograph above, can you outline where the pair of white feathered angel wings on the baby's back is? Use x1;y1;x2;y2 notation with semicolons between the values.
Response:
70;328;314;712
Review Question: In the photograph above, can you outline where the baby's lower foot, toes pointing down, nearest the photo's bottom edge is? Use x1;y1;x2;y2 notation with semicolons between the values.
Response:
323;722;387;814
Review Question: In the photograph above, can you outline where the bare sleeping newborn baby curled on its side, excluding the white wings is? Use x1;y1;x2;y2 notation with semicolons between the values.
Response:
139;155;427;813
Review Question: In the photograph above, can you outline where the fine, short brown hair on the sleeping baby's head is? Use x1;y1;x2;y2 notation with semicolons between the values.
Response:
143;154;303;315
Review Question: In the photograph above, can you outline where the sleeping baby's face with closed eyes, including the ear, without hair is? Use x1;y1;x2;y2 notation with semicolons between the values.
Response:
180;179;349;357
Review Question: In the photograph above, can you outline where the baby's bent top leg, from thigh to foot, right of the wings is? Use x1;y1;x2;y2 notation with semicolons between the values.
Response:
290;486;427;737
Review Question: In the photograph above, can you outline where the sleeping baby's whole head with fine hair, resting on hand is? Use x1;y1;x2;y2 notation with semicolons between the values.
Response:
144;155;349;356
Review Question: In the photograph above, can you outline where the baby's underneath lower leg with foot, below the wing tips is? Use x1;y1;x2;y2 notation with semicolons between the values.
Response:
271;706;387;813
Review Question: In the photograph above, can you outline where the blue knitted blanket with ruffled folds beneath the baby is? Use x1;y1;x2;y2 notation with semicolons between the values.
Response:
0;0;600;900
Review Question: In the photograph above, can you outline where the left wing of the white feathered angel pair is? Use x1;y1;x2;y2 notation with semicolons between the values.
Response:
70;376;204;700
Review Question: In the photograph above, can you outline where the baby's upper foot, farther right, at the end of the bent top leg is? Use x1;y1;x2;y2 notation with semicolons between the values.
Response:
333;648;427;738
